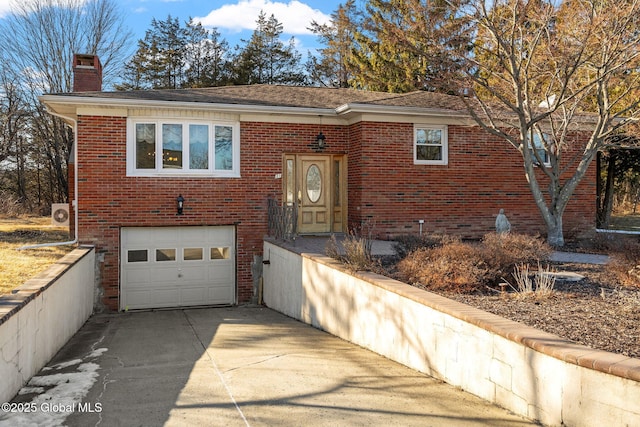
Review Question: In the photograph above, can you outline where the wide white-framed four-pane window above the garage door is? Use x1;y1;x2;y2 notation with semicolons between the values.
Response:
127;119;240;176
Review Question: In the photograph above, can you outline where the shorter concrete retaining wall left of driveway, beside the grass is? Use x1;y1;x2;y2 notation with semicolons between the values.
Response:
0;247;95;403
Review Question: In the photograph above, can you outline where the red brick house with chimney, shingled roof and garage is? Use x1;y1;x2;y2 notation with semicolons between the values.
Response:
42;55;596;310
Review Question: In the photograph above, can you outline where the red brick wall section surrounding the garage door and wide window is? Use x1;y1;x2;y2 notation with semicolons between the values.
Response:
78;116;346;310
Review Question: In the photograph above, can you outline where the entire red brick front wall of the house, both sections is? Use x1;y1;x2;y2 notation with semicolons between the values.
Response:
79;116;595;310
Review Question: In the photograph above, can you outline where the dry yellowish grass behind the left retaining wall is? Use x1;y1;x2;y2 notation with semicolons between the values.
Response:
0;217;74;295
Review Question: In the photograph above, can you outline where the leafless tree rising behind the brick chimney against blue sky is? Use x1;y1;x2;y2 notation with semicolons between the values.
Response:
0;0;130;213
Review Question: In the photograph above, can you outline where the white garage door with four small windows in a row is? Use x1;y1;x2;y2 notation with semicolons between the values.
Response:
120;226;236;310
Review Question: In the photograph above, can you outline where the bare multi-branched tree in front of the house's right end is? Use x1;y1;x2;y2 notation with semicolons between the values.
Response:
454;0;640;246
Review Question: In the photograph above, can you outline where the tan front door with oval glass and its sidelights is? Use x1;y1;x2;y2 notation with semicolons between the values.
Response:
284;154;346;234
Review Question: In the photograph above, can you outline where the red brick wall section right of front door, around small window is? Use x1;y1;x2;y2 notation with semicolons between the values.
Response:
349;122;596;238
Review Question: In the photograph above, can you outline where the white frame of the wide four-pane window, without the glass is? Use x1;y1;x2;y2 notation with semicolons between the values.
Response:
127;117;240;178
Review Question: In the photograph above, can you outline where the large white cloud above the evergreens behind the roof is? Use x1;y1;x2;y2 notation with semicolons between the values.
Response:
194;0;331;35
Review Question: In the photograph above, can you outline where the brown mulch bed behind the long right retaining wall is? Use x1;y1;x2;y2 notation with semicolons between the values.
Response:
424;264;640;358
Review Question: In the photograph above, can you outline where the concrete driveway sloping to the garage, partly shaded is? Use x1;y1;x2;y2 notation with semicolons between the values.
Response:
0;307;533;427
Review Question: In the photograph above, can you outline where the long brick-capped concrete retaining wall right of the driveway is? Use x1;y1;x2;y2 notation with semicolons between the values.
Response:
263;241;640;427
